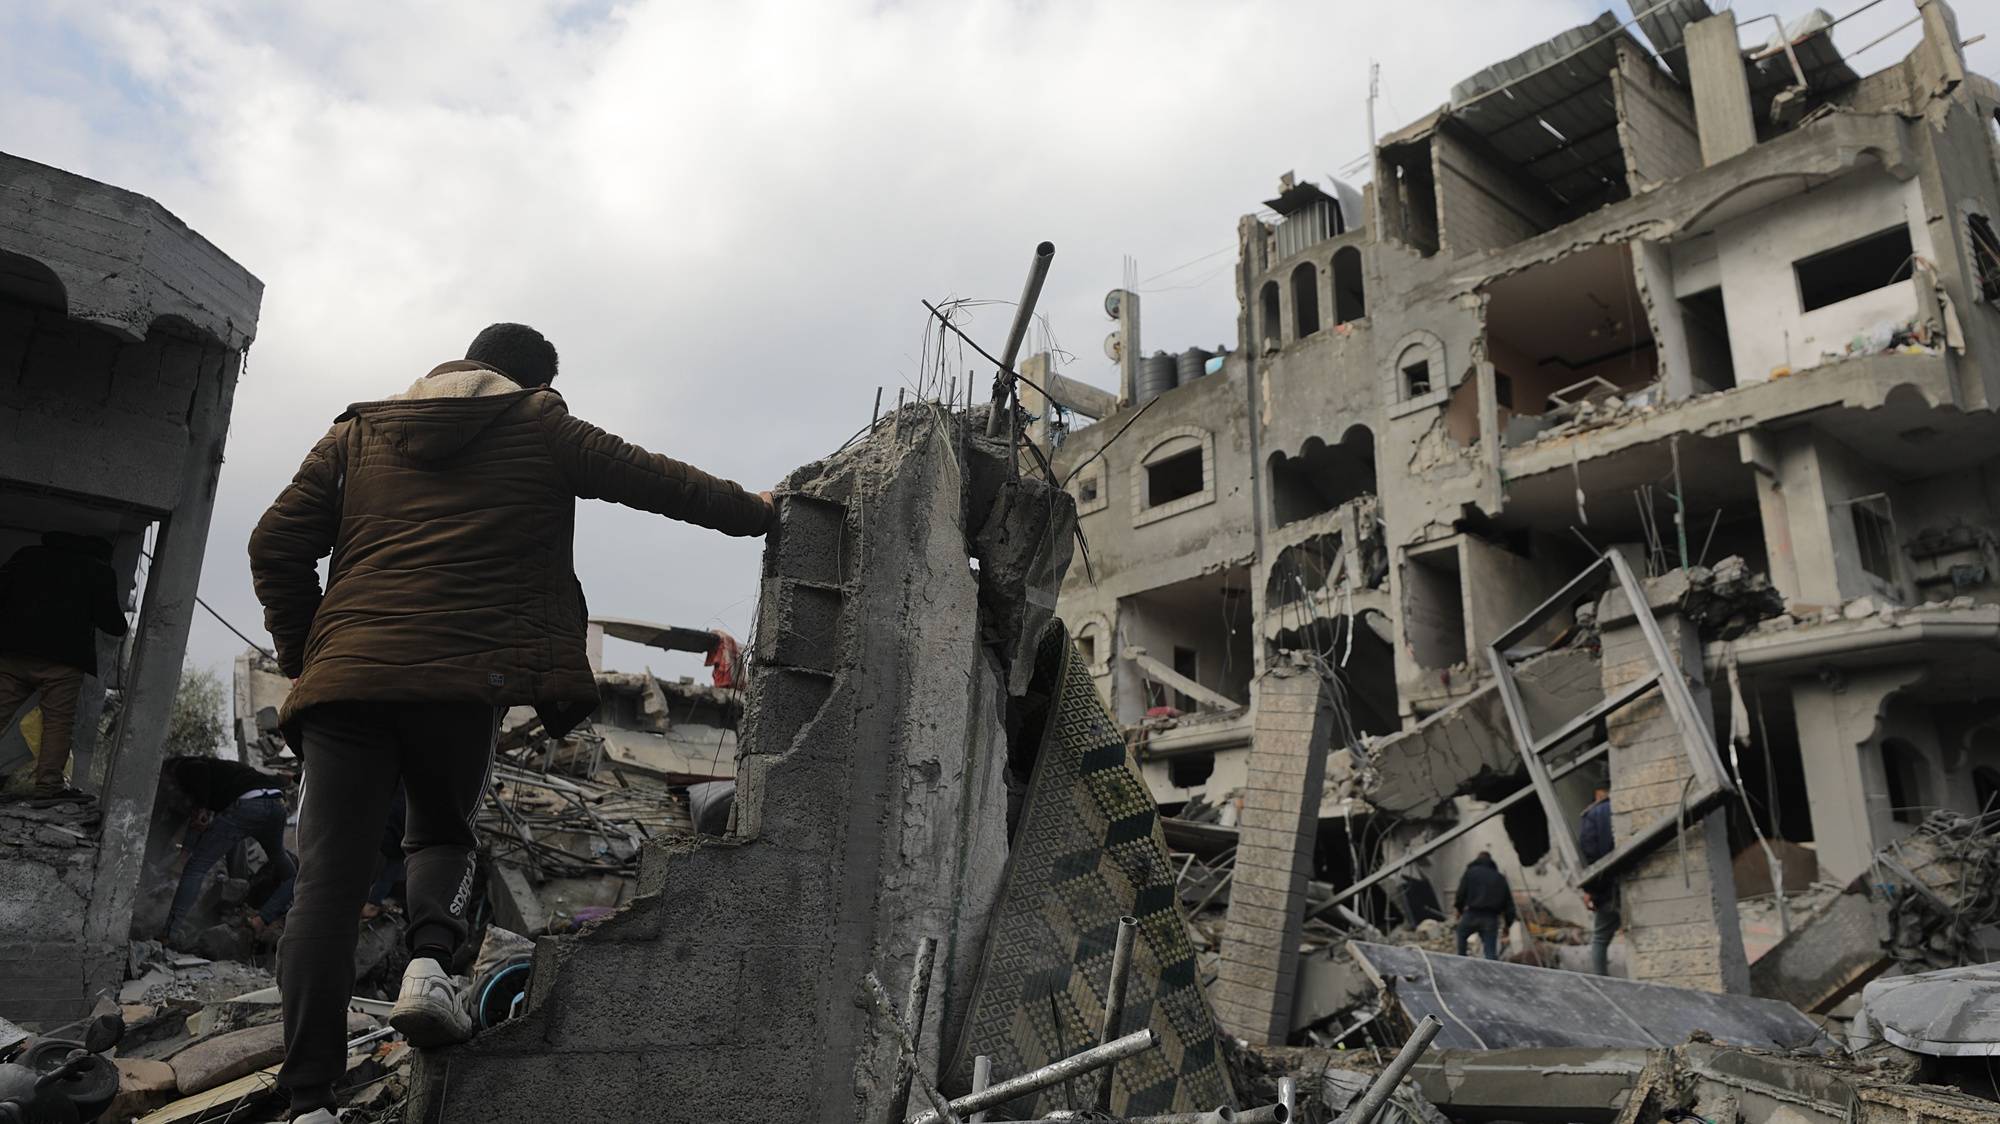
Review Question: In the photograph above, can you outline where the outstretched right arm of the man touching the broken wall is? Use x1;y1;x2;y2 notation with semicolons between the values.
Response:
542;396;776;536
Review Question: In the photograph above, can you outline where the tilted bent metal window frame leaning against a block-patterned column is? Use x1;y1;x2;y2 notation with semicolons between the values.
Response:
1486;550;1736;888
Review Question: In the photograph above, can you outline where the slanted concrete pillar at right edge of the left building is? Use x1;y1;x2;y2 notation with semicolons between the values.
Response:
84;352;240;968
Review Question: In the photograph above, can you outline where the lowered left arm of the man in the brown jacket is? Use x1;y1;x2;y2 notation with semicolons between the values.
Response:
250;426;340;680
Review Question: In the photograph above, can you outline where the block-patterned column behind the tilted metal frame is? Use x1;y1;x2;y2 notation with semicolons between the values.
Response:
1598;576;1750;994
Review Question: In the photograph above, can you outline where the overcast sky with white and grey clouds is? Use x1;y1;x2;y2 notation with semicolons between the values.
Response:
0;0;2000;674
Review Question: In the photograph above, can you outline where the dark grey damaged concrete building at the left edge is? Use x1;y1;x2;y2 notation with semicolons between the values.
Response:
0;154;264;1024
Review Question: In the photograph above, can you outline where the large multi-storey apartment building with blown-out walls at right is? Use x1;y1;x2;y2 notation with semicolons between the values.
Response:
1030;0;2000;1042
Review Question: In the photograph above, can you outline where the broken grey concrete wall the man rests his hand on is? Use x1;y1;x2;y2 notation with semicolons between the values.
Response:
420;406;1070;1122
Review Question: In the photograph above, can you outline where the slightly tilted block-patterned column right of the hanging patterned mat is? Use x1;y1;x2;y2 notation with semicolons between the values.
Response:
1214;664;1332;1046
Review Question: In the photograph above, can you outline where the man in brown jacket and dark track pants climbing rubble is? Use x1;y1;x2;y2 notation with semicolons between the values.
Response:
250;324;776;1124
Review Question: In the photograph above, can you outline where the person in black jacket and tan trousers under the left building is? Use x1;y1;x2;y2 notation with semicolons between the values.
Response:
0;532;126;804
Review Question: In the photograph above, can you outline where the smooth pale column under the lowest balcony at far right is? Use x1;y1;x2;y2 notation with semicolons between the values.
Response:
1792;666;1924;882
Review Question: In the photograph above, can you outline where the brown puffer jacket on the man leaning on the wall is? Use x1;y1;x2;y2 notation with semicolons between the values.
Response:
250;360;770;744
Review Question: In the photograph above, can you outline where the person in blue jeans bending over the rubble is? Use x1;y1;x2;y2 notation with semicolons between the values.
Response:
162;756;298;942
